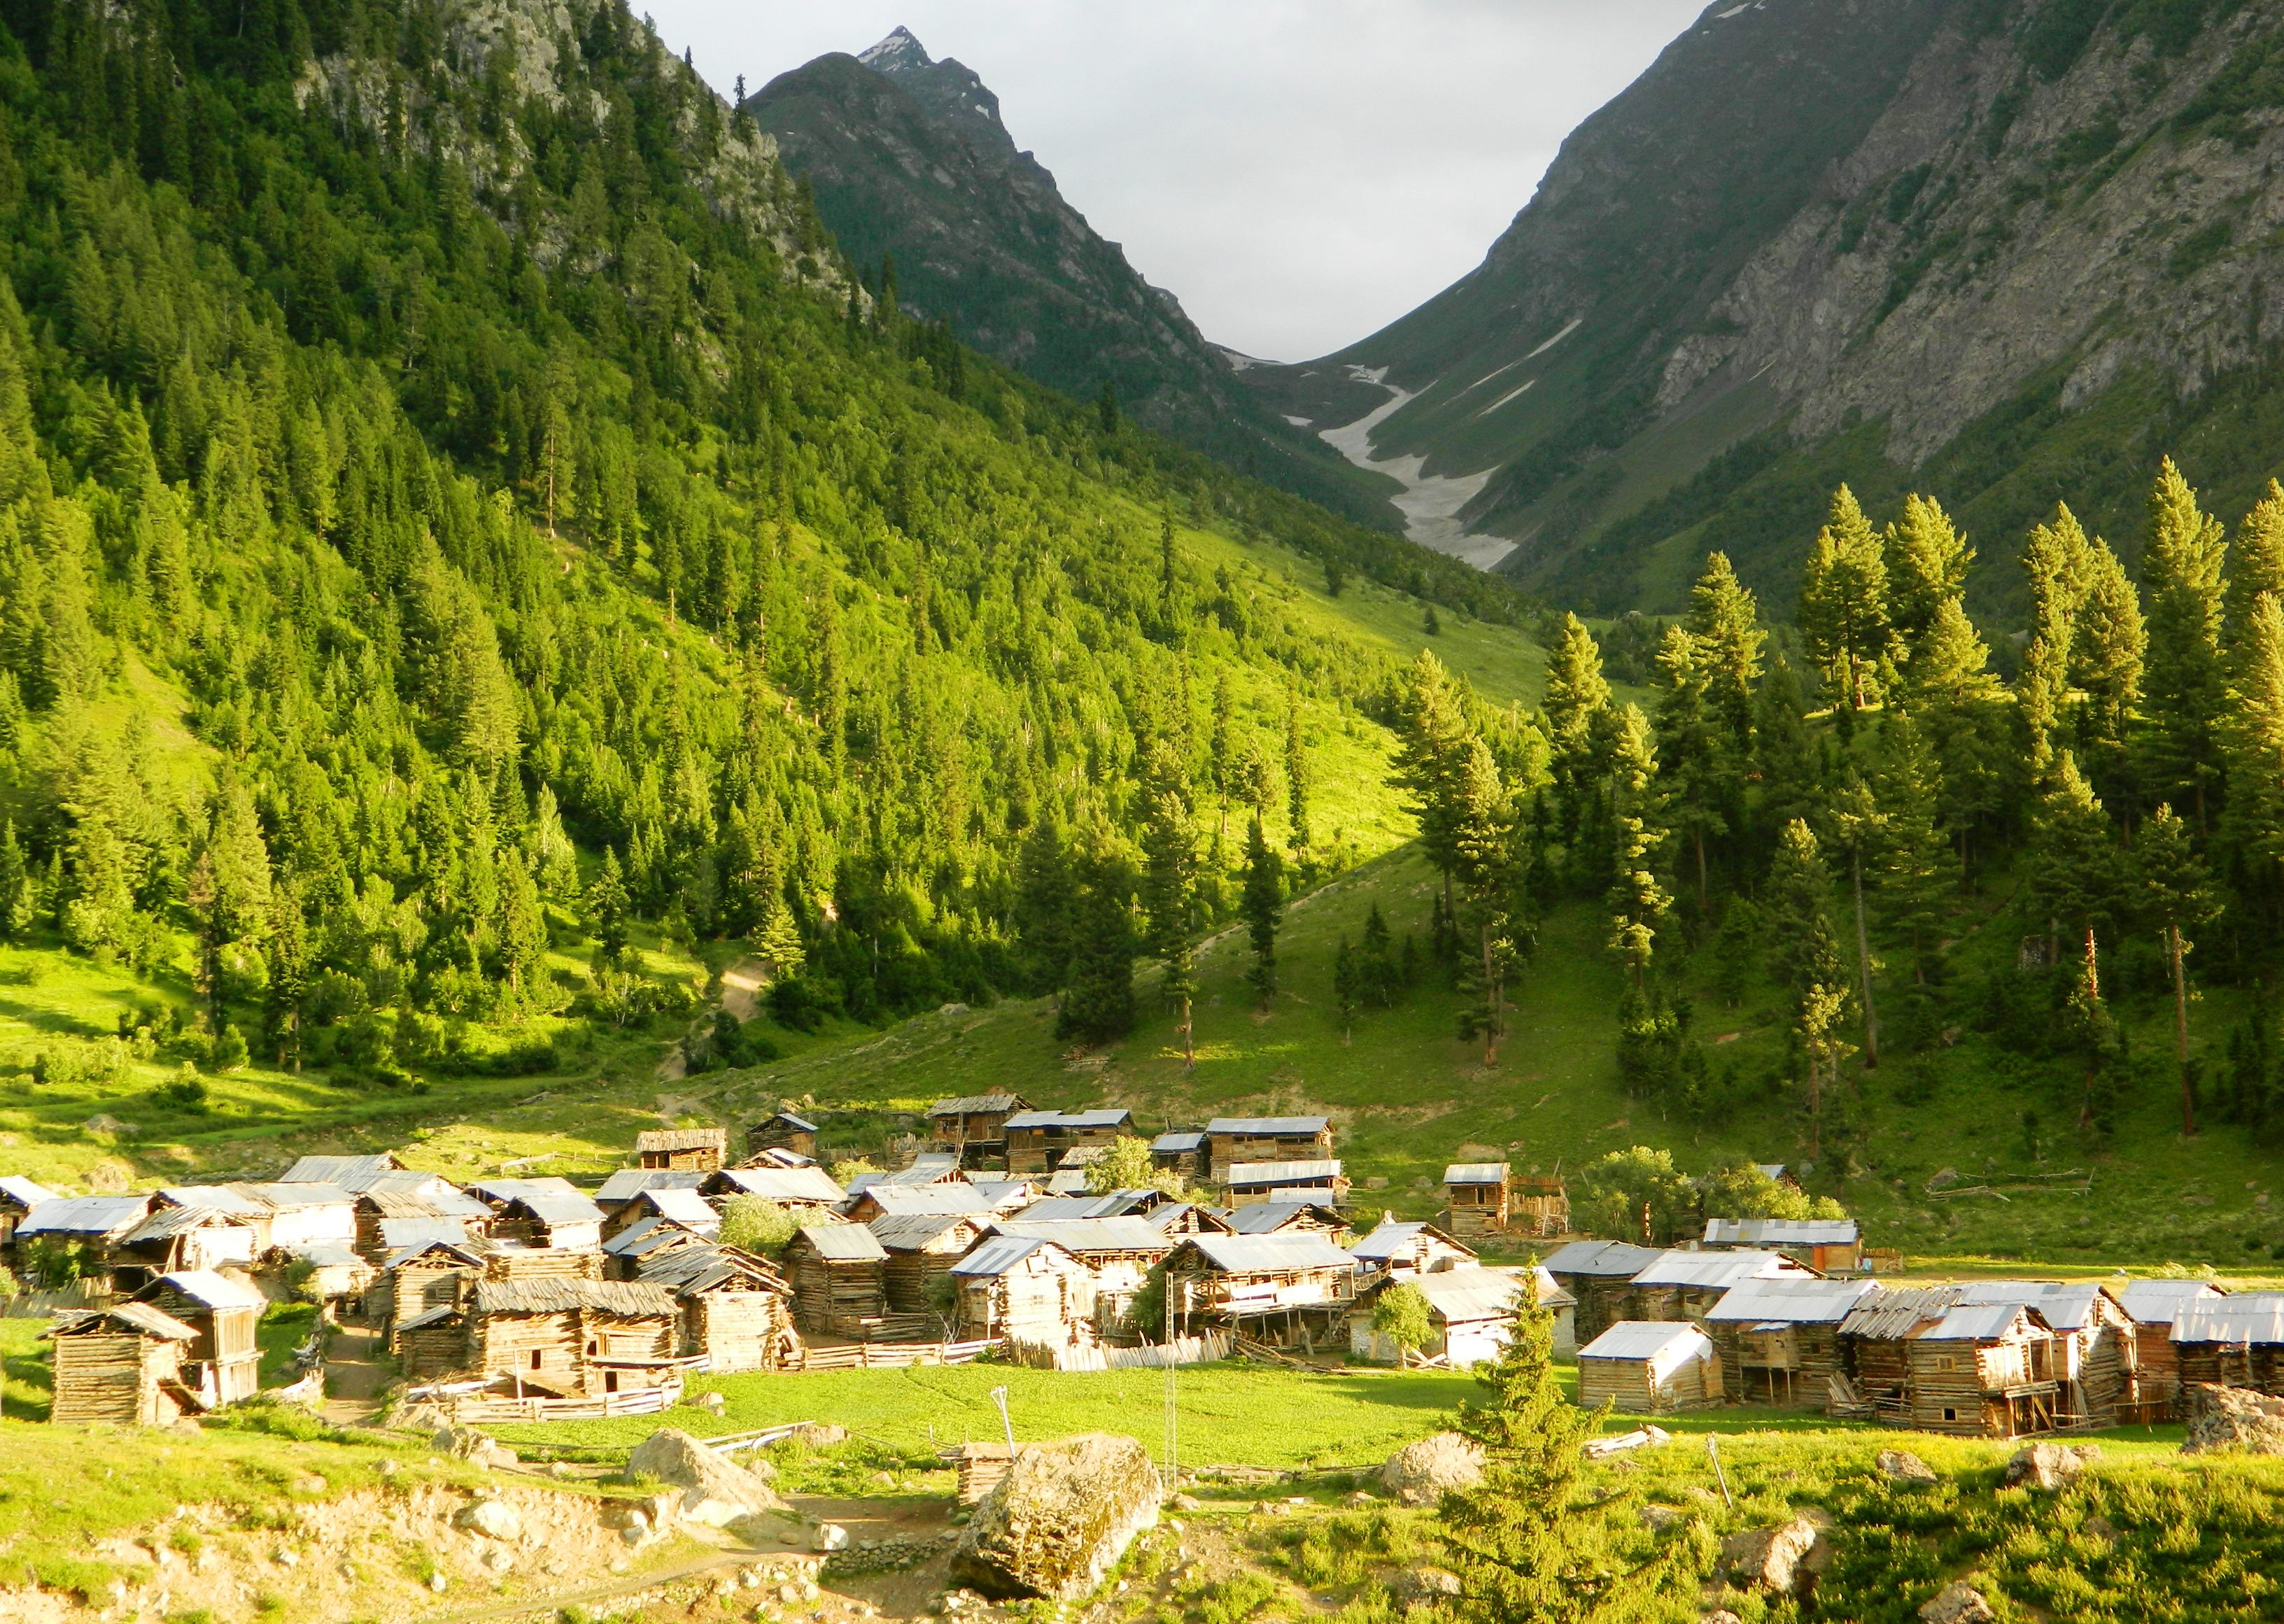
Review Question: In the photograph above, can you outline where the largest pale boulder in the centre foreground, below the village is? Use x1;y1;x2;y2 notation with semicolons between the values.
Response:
952;1432;1165;1601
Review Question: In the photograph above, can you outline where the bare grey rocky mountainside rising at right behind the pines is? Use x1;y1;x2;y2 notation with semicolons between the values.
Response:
1268;0;2284;607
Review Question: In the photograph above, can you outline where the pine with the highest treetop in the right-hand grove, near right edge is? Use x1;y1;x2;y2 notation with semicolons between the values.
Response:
2140;457;2229;831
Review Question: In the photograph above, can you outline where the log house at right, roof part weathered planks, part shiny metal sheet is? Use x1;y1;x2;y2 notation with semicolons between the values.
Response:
1829;1286;2069;1439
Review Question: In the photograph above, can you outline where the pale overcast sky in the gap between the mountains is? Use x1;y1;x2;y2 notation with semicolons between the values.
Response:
640;0;1704;361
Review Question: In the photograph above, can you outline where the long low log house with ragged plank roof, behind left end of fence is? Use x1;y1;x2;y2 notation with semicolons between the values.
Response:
464;1279;685;1396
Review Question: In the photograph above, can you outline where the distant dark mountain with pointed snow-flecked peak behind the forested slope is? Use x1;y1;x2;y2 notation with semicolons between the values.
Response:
745;29;1393;525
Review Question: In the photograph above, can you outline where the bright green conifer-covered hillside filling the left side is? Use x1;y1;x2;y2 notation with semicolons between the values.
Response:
0;0;1519;1178
